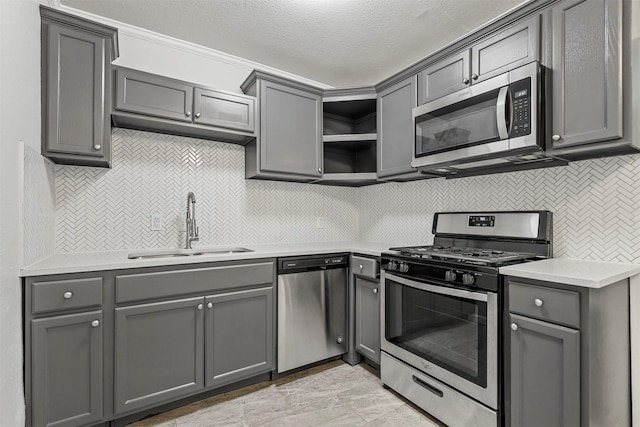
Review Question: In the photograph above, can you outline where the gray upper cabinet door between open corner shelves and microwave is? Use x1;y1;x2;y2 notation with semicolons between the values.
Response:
377;76;419;178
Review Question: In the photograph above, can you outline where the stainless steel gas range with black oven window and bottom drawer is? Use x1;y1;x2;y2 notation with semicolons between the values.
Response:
380;211;552;426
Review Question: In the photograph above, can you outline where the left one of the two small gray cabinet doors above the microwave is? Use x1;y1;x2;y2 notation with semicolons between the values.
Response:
418;49;470;105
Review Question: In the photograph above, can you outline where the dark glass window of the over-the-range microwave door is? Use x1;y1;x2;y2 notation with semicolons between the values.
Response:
415;89;500;157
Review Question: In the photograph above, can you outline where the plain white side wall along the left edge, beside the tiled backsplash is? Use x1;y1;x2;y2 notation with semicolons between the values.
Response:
0;0;40;426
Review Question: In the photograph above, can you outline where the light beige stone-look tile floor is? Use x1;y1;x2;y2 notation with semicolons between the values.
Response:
130;361;442;427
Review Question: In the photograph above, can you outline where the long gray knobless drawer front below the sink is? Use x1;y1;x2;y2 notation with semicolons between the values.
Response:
116;262;275;303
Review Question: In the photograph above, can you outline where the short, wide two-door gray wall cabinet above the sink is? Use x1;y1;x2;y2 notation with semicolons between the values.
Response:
112;67;255;144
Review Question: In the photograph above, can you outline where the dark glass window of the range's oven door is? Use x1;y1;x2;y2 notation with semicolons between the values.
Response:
384;279;487;387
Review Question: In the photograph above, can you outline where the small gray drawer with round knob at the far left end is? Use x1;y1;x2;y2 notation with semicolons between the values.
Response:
31;277;102;314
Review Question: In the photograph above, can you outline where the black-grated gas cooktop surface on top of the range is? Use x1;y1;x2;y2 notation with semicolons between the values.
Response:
389;245;537;267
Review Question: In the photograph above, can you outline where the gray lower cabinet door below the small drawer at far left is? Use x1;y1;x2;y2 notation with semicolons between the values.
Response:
31;311;103;427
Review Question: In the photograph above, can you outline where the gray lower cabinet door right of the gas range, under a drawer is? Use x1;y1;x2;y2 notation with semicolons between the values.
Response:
510;314;580;427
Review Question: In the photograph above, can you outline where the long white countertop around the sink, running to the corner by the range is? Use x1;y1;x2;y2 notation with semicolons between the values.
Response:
20;241;394;277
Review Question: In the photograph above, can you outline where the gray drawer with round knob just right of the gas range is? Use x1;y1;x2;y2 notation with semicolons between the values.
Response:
509;282;580;328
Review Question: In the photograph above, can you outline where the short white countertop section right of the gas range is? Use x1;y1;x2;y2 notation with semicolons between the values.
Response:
500;258;640;289
